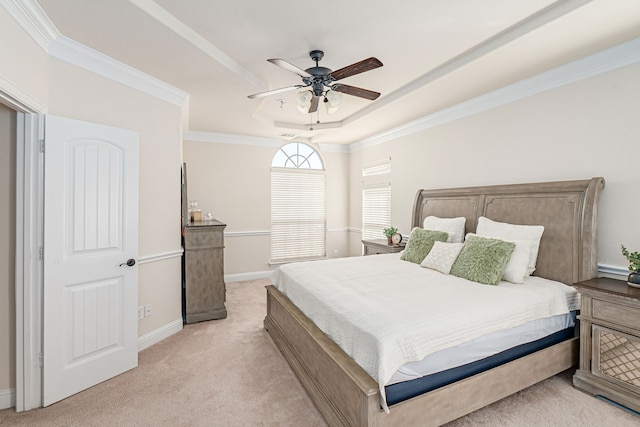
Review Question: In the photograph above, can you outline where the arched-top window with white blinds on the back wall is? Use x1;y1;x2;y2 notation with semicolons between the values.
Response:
271;142;326;262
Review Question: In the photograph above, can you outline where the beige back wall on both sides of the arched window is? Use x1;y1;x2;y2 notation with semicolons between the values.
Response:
183;139;349;275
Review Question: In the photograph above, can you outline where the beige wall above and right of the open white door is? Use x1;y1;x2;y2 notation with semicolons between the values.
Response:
49;59;182;336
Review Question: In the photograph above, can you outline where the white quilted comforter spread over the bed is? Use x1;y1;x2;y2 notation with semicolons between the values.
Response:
271;254;579;410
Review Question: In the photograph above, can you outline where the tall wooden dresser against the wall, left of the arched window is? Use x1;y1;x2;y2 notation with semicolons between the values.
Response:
183;220;227;323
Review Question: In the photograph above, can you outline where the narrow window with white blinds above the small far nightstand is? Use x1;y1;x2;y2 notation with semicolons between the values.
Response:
362;158;391;239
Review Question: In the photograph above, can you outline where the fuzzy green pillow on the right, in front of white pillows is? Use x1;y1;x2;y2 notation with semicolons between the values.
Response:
450;235;516;285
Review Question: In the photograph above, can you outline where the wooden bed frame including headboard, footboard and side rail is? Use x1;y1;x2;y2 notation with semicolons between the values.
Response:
264;178;604;427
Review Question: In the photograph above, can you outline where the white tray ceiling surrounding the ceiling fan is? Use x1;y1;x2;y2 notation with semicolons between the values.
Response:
37;0;640;144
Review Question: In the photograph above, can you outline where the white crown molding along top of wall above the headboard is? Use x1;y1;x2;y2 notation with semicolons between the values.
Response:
349;38;640;152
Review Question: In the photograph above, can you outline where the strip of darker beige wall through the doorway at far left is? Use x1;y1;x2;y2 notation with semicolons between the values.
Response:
0;104;16;390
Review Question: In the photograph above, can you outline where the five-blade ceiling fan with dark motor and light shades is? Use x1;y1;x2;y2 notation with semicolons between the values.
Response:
249;50;382;113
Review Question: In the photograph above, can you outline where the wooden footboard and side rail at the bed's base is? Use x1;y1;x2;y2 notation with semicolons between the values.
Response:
264;286;578;427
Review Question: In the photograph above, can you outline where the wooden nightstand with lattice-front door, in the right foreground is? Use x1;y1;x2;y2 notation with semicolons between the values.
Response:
573;278;640;411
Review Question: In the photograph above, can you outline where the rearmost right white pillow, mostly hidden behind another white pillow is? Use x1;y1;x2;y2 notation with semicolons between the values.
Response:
476;216;544;275
